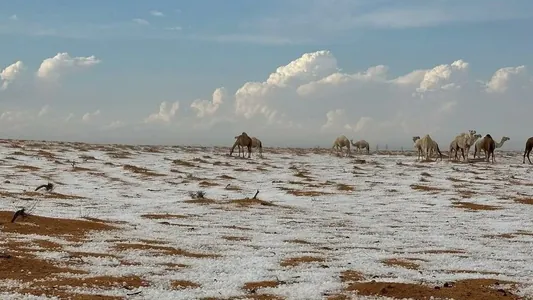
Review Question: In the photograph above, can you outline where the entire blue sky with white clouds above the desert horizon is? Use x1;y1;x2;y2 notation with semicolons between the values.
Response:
0;0;533;150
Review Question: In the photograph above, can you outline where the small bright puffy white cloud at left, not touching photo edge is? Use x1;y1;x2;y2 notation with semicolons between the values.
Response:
37;52;101;80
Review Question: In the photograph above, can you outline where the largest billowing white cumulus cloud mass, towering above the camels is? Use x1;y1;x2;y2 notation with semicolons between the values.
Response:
181;50;533;145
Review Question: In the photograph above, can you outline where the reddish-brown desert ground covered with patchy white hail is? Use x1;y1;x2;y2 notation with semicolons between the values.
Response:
0;140;533;300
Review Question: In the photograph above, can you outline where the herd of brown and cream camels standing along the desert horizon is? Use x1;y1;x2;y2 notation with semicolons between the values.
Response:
229;130;533;164
